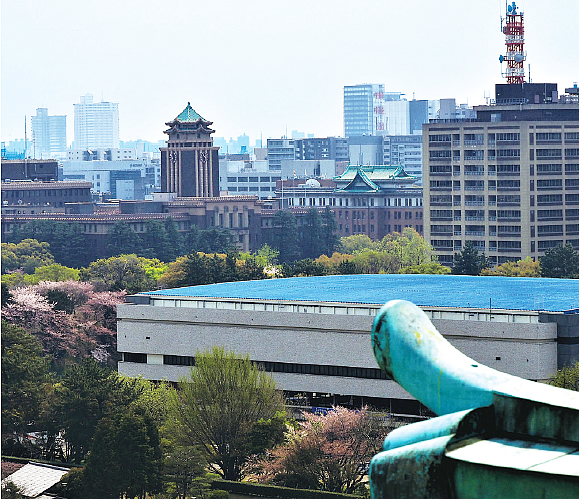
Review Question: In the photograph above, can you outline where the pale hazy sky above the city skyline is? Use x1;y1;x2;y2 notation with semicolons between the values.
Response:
1;0;579;144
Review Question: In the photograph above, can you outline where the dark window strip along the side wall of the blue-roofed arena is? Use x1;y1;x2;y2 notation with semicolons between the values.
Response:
123;352;390;379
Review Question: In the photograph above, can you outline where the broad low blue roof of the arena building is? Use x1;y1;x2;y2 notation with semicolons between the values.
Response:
141;274;579;313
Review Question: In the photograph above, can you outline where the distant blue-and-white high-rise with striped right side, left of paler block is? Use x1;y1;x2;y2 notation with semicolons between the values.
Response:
344;84;386;137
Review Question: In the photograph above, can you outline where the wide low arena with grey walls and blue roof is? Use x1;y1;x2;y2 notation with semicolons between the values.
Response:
118;275;579;414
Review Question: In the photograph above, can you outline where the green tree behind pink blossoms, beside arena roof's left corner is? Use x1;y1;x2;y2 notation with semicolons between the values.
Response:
81;254;160;294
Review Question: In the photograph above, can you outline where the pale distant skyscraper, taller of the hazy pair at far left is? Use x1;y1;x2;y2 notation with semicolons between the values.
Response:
74;94;119;149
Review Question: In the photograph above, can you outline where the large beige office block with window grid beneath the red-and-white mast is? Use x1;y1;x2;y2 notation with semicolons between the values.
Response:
423;98;579;265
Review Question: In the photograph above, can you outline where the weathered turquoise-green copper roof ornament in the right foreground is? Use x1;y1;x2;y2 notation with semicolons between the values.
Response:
370;300;579;499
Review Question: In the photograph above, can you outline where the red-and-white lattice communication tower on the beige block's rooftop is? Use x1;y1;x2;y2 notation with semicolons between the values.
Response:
499;2;527;83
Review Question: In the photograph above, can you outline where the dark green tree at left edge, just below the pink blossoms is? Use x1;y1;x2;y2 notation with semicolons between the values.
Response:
2;320;49;444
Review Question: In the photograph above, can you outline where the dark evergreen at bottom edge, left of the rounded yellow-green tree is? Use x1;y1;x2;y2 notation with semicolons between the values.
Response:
84;411;163;499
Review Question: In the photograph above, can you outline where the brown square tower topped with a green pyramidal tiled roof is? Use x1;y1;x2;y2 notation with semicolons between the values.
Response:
161;102;219;197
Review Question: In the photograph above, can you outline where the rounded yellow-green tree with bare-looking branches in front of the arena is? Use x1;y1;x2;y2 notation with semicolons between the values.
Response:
171;347;284;480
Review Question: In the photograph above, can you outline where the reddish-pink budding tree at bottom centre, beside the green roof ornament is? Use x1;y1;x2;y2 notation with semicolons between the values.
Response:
257;407;389;494
